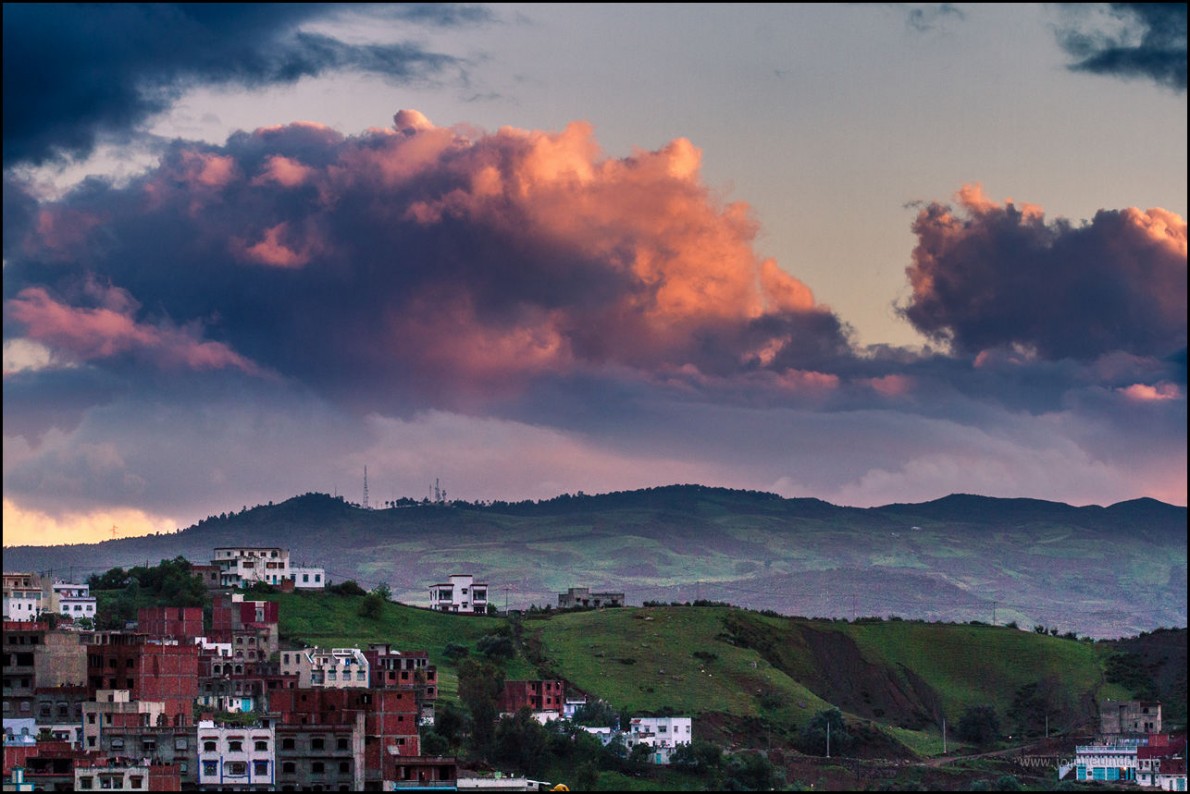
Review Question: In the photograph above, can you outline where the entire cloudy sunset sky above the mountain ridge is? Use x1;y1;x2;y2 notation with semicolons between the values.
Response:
4;4;1188;545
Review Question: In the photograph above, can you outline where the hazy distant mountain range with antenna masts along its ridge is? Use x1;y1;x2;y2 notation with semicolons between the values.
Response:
5;486;1186;637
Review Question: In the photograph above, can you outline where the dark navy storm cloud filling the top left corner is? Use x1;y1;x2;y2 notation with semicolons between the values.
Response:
4;4;486;168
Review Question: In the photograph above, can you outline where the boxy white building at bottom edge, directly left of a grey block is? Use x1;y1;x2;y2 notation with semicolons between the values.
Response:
199;720;276;789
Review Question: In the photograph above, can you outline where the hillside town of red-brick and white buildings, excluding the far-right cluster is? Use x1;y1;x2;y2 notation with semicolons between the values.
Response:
4;546;693;792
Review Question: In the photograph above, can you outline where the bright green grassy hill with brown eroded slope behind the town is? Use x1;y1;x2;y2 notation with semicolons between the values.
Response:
267;593;1185;755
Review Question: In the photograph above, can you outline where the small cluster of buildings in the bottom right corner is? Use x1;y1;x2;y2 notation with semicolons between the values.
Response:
1058;700;1186;792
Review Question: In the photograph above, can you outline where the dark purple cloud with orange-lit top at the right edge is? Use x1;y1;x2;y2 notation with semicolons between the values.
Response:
902;186;1186;360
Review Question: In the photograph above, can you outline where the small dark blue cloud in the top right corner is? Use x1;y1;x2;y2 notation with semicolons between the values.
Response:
1058;2;1186;90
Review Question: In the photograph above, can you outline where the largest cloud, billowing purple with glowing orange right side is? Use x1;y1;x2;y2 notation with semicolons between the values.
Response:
5;111;850;407
